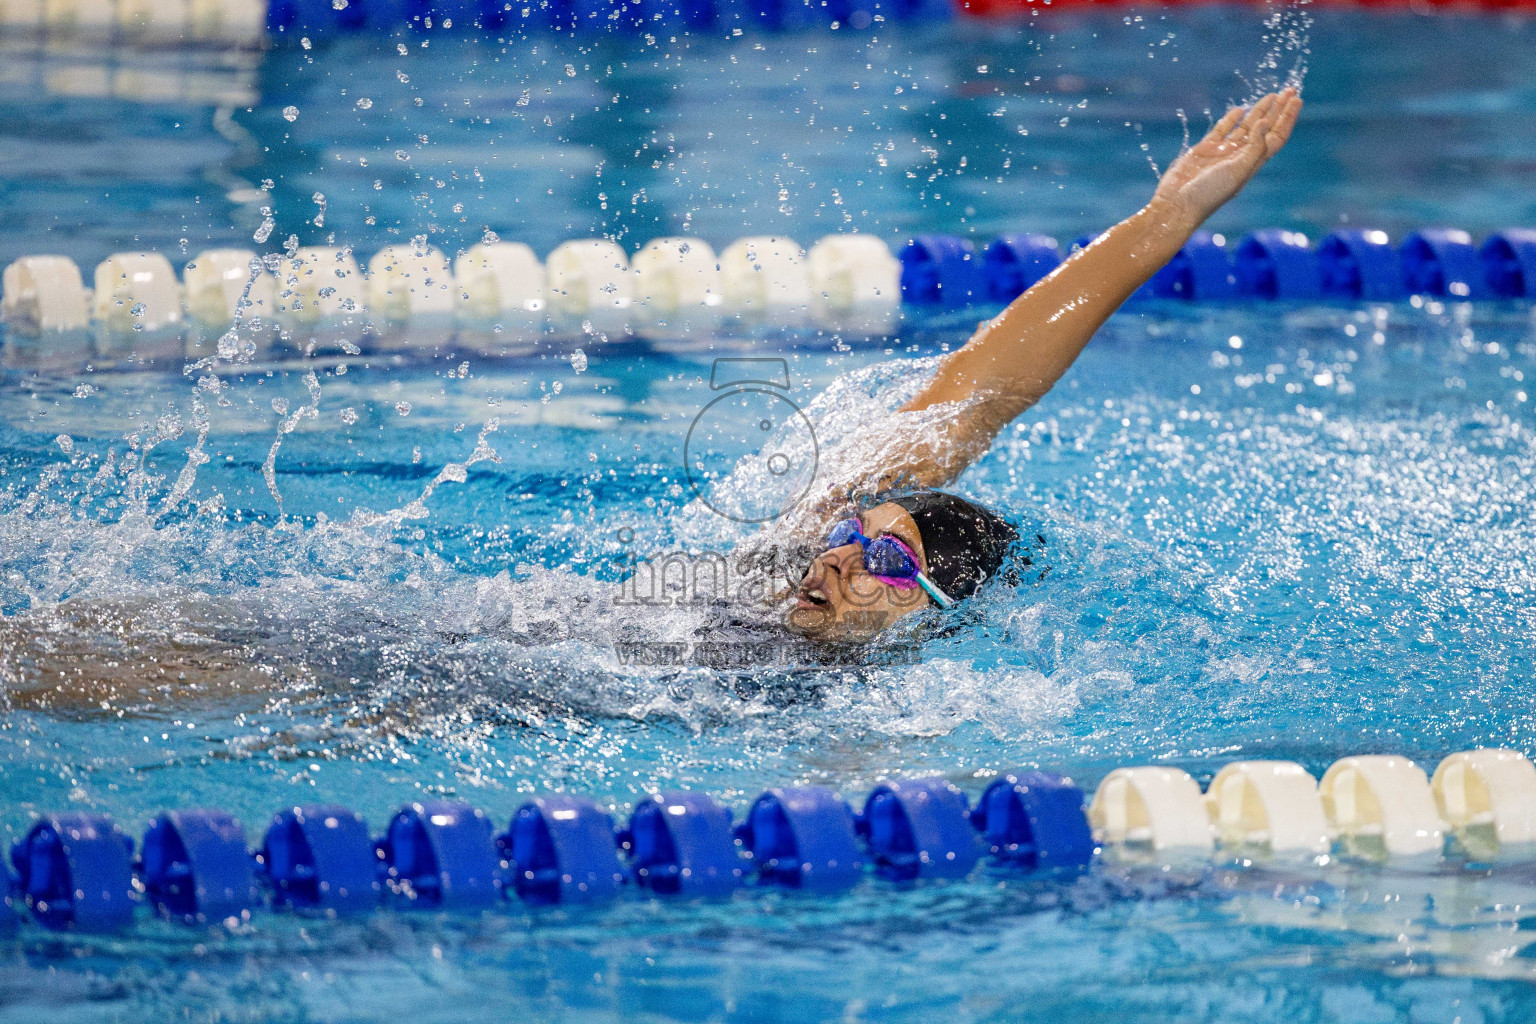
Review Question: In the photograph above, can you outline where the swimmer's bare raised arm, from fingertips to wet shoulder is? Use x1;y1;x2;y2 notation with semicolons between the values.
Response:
892;89;1301;487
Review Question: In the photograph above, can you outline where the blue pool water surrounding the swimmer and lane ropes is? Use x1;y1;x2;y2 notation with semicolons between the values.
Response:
0;9;1536;1024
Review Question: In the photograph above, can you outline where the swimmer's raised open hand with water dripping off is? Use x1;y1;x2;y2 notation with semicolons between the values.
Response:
1152;89;1301;224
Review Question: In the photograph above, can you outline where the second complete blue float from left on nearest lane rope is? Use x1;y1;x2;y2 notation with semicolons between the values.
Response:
138;811;257;924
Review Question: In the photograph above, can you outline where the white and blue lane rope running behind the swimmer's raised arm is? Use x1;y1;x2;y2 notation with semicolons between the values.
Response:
0;227;1536;358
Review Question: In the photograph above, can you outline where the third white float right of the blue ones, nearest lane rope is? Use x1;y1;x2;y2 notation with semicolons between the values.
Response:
1318;754;1445;861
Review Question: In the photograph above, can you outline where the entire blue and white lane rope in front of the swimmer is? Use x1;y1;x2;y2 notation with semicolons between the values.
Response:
9;749;1536;930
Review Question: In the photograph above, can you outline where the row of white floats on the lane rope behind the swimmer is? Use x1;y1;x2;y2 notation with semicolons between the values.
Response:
0;234;900;356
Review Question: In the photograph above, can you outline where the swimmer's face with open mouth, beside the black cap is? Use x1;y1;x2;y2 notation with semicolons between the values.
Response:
785;502;929;642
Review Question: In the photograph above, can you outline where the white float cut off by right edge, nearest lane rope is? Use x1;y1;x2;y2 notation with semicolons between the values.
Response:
1430;749;1536;863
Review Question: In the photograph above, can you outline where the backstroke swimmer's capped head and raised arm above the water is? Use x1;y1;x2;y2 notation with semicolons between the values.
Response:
785;89;1301;642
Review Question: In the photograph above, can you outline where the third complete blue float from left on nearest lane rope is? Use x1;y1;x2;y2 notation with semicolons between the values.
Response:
257;804;382;915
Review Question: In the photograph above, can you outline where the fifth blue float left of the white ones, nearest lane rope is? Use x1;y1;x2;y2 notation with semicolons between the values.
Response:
496;797;624;904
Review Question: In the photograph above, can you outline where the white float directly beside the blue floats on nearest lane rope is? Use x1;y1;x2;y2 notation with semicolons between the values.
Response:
1087;768;1213;857
